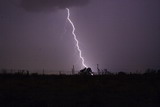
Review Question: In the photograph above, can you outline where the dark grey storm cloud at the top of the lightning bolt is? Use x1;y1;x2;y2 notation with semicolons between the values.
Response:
20;0;90;11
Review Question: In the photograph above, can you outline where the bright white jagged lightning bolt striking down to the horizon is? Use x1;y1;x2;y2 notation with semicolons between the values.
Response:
66;8;88;68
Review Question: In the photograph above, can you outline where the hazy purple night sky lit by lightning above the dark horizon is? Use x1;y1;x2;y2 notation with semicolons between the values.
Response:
0;0;160;73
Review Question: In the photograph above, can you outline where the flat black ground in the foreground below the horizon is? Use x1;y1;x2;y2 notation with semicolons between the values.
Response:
0;74;160;107
